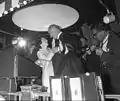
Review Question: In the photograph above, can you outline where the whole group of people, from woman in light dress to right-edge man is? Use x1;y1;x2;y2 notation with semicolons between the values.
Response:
35;24;120;93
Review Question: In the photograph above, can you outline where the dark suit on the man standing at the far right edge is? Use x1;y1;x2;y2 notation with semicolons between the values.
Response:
102;32;120;94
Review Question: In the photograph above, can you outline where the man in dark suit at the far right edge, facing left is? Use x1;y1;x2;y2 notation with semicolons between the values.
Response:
96;23;120;93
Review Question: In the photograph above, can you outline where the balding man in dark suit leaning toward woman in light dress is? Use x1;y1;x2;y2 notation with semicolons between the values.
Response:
48;24;84;76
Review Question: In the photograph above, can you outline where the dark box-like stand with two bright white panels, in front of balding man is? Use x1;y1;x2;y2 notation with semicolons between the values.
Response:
50;73;104;101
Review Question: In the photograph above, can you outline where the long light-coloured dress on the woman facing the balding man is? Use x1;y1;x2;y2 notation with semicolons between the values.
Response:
36;48;54;92
